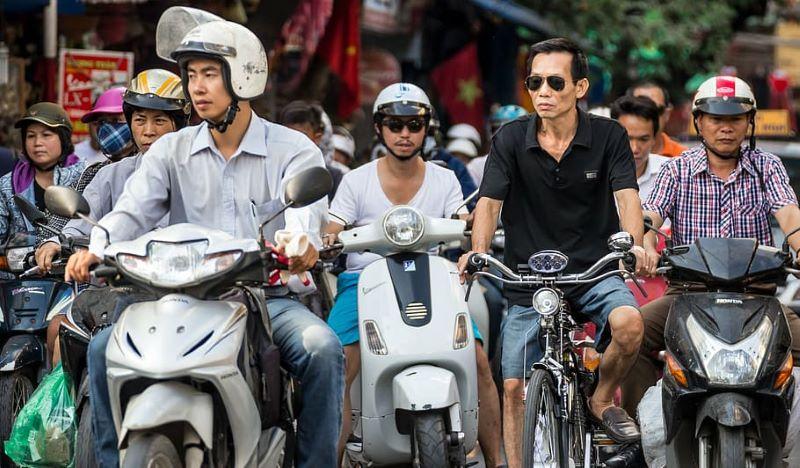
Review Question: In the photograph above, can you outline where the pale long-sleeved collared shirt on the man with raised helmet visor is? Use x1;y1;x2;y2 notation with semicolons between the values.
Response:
89;113;328;257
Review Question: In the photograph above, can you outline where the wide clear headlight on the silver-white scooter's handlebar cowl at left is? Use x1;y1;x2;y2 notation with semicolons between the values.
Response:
117;240;242;288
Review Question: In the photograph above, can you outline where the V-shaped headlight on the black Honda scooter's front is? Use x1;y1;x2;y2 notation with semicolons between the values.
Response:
686;315;772;385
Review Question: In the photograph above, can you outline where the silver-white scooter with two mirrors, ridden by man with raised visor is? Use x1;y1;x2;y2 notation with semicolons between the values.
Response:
45;168;331;468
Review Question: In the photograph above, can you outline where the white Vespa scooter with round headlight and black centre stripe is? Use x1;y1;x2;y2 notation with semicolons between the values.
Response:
339;206;478;468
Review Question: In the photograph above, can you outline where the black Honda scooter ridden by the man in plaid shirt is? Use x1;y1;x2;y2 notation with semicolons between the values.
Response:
658;226;800;468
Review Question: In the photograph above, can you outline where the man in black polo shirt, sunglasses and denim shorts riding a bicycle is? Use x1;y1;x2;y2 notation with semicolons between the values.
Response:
459;38;646;467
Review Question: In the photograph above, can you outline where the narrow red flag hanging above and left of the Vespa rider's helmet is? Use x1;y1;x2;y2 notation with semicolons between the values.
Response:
318;0;361;119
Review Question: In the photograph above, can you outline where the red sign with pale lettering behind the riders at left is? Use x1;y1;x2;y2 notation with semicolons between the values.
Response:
58;49;133;141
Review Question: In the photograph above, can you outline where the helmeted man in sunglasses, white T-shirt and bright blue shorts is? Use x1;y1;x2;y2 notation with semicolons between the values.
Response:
325;83;502;467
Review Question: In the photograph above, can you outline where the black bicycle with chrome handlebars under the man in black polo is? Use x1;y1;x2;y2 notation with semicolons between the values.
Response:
467;232;646;468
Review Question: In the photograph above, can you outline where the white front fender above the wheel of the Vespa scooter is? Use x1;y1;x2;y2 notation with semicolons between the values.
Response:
392;365;460;411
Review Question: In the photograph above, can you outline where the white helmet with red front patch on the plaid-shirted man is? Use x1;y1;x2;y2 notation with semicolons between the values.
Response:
692;76;756;117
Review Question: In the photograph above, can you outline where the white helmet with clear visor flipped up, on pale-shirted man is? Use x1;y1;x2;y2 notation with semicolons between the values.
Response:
156;7;267;101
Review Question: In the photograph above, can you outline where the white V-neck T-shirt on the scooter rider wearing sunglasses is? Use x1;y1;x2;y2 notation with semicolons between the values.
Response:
330;159;464;272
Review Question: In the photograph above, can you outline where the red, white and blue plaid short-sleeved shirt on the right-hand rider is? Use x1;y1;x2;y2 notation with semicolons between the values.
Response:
642;146;797;245
